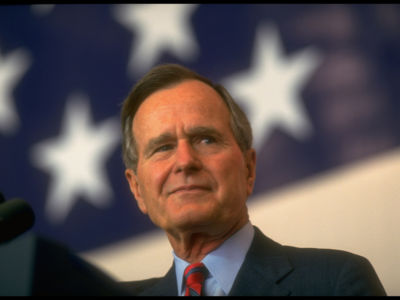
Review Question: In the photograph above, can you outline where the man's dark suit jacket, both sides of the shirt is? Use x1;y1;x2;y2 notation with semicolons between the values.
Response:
122;227;386;296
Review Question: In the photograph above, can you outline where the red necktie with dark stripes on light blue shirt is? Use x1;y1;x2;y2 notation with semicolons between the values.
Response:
183;262;207;296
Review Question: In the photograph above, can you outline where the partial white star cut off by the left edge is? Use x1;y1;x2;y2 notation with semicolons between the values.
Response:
0;49;30;134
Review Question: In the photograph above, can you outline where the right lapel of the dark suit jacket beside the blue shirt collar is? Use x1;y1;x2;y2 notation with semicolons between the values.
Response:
230;227;292;296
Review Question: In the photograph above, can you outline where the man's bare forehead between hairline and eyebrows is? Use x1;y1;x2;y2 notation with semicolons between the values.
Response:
133;80;230;130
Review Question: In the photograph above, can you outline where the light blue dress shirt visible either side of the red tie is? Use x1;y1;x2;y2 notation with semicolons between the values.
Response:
172;222;254;295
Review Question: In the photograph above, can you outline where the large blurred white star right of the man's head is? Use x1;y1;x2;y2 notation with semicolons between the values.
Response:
224;24;320;150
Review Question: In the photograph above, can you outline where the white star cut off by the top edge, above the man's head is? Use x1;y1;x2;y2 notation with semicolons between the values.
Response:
115;4;199;75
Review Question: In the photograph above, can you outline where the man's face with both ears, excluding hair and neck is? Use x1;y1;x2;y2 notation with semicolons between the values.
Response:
126;80;255;233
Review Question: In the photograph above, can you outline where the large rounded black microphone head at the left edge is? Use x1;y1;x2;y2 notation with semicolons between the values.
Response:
0;198;35;243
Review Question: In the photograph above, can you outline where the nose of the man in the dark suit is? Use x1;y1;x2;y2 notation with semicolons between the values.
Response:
174;140;202;173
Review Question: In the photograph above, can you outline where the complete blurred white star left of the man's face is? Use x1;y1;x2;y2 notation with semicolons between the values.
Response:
32;95;120;223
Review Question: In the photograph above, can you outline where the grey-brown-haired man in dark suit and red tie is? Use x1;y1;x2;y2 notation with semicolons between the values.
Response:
122;64;385;295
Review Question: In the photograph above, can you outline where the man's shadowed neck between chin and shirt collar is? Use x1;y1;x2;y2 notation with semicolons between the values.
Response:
167;218;248;263
